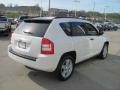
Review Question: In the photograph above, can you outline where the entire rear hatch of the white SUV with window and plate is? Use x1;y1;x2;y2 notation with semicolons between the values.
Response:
11;20;51;57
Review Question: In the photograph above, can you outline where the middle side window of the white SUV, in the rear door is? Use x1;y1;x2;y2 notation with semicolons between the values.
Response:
72;22;85;36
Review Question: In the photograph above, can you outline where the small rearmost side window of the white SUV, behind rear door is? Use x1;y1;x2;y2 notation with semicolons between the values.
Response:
60;22;71;36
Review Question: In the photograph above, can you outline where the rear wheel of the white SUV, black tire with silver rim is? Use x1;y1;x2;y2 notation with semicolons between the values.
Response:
55;55;75;81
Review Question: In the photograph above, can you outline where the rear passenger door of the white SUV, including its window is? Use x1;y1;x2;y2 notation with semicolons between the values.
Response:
71;22;90;63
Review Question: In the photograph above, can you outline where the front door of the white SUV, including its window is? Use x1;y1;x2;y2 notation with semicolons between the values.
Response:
81;23;103;56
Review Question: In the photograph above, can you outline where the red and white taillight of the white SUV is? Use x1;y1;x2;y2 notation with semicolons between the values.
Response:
41;38;54;54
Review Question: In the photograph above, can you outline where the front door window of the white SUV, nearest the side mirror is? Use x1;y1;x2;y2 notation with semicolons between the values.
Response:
80;23;98;36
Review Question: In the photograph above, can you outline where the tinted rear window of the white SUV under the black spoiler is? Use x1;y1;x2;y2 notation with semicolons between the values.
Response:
15;20;51;37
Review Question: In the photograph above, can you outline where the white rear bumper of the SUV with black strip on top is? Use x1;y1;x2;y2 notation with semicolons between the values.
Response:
8;47;59;72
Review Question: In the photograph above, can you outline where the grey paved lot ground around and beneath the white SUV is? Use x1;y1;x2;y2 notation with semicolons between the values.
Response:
0;30;120;90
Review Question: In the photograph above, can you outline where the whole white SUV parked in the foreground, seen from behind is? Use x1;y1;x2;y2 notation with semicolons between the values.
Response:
8;17;109;80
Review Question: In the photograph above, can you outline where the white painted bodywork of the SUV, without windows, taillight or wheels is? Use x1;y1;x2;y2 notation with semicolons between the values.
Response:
8;19;108;72
